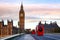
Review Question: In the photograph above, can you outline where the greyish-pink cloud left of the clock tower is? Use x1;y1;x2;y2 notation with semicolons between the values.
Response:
0;4;19;19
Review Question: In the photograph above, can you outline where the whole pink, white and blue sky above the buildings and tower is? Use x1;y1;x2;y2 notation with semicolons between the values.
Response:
0;0;60;29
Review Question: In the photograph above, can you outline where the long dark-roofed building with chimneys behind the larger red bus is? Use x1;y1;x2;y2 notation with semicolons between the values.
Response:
39;21;59;33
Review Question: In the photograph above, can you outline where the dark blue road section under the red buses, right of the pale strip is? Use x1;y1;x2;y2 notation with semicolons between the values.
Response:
32;34;60;40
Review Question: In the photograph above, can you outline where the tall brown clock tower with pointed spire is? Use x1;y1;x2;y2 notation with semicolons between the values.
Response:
19;4;25;32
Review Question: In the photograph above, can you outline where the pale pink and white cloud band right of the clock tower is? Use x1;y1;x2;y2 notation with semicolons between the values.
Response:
25;4;60;15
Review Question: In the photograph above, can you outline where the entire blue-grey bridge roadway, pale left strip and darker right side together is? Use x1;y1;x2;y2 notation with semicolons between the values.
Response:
5;34;60;40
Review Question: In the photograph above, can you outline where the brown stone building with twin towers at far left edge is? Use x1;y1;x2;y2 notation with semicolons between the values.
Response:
0;20;13;37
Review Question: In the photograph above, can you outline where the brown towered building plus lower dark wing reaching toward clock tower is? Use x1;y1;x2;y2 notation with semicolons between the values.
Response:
0;20;19;37
